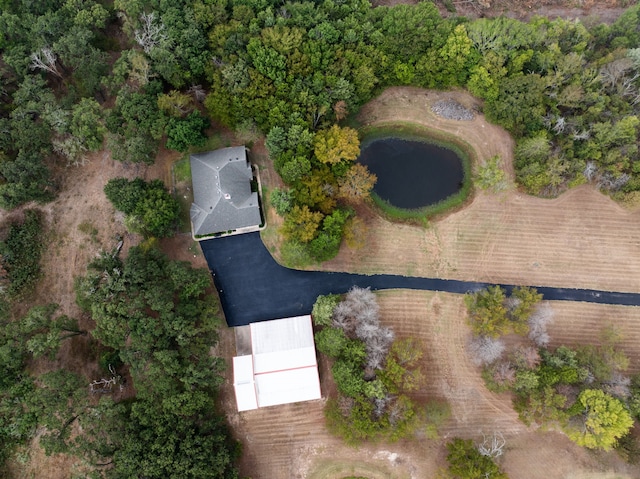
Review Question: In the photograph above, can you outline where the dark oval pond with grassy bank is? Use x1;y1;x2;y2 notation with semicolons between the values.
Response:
358;138;464;209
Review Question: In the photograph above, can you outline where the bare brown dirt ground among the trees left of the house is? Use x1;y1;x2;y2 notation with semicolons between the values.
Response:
1;146;206;479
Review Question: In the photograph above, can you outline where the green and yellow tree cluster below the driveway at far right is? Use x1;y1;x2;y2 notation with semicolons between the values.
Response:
466;286;640;450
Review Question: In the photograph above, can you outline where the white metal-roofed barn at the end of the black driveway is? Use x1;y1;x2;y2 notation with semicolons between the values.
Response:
233;316;321;411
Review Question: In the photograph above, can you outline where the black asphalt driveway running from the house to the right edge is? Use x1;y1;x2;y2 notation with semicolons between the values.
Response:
200;233;640;326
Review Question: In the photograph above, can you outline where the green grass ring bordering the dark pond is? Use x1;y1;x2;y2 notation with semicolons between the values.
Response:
360;122;477;226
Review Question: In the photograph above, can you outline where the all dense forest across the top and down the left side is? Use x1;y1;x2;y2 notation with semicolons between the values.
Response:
0;0;640;478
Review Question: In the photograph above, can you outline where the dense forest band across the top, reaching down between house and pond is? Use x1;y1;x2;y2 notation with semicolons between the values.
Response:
0;0;640;261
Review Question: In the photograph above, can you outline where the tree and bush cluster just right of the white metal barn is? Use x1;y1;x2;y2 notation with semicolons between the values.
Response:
313;287;432;443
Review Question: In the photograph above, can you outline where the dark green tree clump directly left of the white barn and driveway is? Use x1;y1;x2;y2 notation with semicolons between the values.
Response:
72;247;239;479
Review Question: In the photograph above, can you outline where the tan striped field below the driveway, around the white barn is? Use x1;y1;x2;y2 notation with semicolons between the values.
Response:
219;291;640;479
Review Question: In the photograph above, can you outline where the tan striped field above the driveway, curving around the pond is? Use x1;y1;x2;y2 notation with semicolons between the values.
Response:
322;88;640;292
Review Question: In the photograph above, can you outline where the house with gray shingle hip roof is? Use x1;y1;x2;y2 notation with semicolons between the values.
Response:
190;146;262;240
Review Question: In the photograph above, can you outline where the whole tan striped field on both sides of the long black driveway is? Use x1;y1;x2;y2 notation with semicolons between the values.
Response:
241;88;640;479
